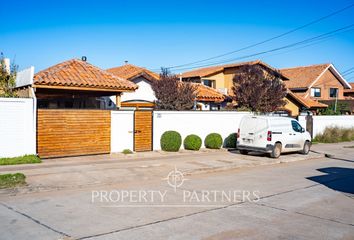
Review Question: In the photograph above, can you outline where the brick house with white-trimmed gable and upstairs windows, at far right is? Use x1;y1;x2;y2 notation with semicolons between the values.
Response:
280;63;352;112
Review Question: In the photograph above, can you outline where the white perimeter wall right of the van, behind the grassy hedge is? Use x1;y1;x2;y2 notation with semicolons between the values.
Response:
299;115;354;137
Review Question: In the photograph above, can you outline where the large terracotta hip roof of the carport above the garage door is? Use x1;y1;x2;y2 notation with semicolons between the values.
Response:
33;59;138;90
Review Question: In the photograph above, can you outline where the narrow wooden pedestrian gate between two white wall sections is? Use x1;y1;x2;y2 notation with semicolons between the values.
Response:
134;111;152;152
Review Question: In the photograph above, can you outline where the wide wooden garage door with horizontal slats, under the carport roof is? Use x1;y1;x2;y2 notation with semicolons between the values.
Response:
37;109;111;158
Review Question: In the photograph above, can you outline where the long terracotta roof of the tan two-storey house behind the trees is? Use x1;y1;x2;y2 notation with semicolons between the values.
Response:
182;60;286;78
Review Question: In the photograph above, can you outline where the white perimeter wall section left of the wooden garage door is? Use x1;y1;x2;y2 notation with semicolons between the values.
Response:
0;98;36;157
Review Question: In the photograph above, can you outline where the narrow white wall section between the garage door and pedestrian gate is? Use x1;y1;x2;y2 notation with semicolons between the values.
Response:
111;111;134;152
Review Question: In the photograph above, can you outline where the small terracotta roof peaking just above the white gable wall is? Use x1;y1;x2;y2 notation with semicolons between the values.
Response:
107;64;160;80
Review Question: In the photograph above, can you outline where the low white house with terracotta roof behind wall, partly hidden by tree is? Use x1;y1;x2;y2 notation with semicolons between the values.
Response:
107;63;226;110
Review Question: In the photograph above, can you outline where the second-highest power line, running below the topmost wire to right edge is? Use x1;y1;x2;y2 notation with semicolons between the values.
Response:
168;24;354;71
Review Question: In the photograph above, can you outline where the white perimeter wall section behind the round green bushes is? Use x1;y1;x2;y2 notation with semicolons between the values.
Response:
153;111;250;150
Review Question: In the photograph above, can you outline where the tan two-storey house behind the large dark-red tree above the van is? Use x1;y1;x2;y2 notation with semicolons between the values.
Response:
181;60;309;116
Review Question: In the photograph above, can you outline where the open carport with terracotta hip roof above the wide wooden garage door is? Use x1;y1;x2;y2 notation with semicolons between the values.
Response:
19;59;137;109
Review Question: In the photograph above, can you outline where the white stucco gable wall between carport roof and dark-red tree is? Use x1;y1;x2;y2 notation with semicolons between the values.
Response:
121;77;156;102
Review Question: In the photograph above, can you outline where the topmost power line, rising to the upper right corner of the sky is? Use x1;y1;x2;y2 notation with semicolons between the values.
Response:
162;4;354;69
